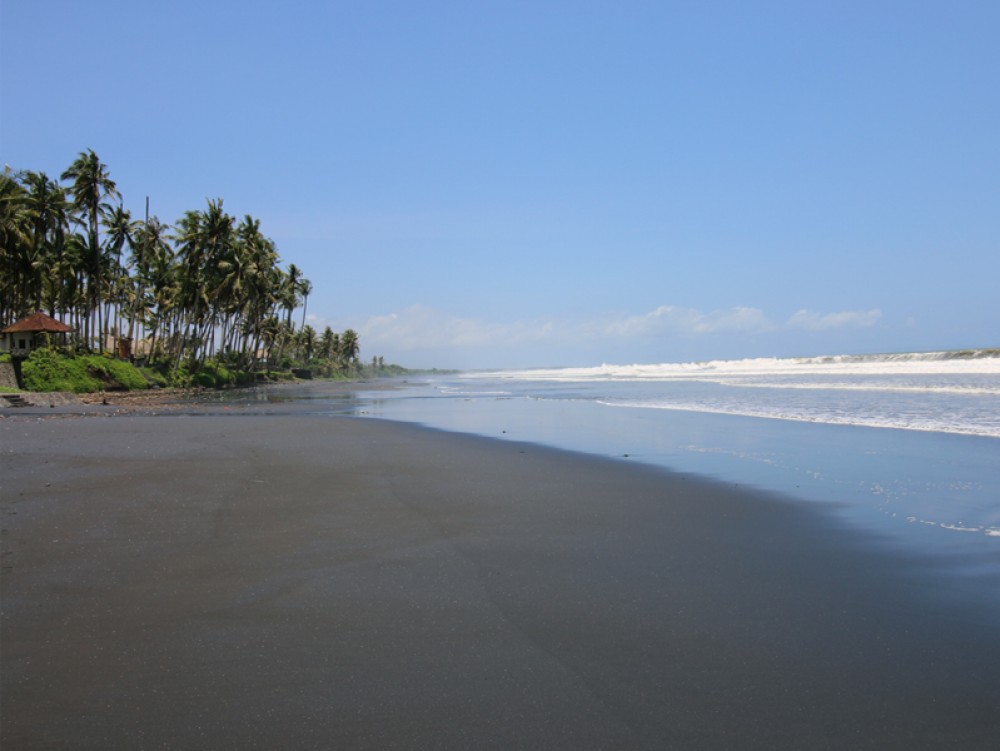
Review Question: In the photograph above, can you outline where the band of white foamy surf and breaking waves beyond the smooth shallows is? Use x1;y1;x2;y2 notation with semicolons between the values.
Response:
466;350;1000;438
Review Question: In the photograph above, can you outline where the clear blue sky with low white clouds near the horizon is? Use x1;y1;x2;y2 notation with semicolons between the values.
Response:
0;0;1000;367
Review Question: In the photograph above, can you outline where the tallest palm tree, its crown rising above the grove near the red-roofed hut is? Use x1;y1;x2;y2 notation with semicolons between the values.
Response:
61;149;120;352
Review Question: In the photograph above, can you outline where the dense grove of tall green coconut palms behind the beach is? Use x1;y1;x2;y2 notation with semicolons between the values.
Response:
0;149;359;371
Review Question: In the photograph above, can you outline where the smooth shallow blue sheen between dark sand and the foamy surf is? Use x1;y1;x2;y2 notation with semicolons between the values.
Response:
350;384;1000;593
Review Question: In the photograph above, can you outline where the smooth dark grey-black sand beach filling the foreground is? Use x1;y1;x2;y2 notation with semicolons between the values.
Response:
0;400;1000;751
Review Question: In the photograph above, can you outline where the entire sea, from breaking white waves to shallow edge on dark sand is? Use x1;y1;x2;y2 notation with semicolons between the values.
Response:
359;350;1000;595
